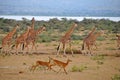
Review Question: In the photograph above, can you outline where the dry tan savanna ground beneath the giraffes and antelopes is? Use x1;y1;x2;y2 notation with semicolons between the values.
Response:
0;33;120;80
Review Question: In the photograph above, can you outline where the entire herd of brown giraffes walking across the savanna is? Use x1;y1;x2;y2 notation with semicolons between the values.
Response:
0;17;120;56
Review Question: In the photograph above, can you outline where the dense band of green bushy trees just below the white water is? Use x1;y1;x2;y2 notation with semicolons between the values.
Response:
0;18;120;33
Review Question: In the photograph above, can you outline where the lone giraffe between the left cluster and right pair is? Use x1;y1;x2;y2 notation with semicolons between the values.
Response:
57;23;77;57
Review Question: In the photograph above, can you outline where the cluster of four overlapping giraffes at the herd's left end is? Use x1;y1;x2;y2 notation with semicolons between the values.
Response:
1;18;46;54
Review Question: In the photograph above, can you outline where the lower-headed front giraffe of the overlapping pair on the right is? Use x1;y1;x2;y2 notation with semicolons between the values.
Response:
83;31;103;54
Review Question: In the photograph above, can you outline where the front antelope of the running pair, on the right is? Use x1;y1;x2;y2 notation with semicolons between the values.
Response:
50;58;72;74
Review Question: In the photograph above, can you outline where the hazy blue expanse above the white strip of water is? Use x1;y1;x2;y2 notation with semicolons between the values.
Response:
0;0;120;14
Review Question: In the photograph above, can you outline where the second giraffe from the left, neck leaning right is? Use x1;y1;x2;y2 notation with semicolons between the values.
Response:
15;26;31;53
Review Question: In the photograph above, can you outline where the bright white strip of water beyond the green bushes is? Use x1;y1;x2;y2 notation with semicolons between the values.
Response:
0;15;120;21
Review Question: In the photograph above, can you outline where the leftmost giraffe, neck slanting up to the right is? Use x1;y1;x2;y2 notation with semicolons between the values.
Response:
2;24;19;51
